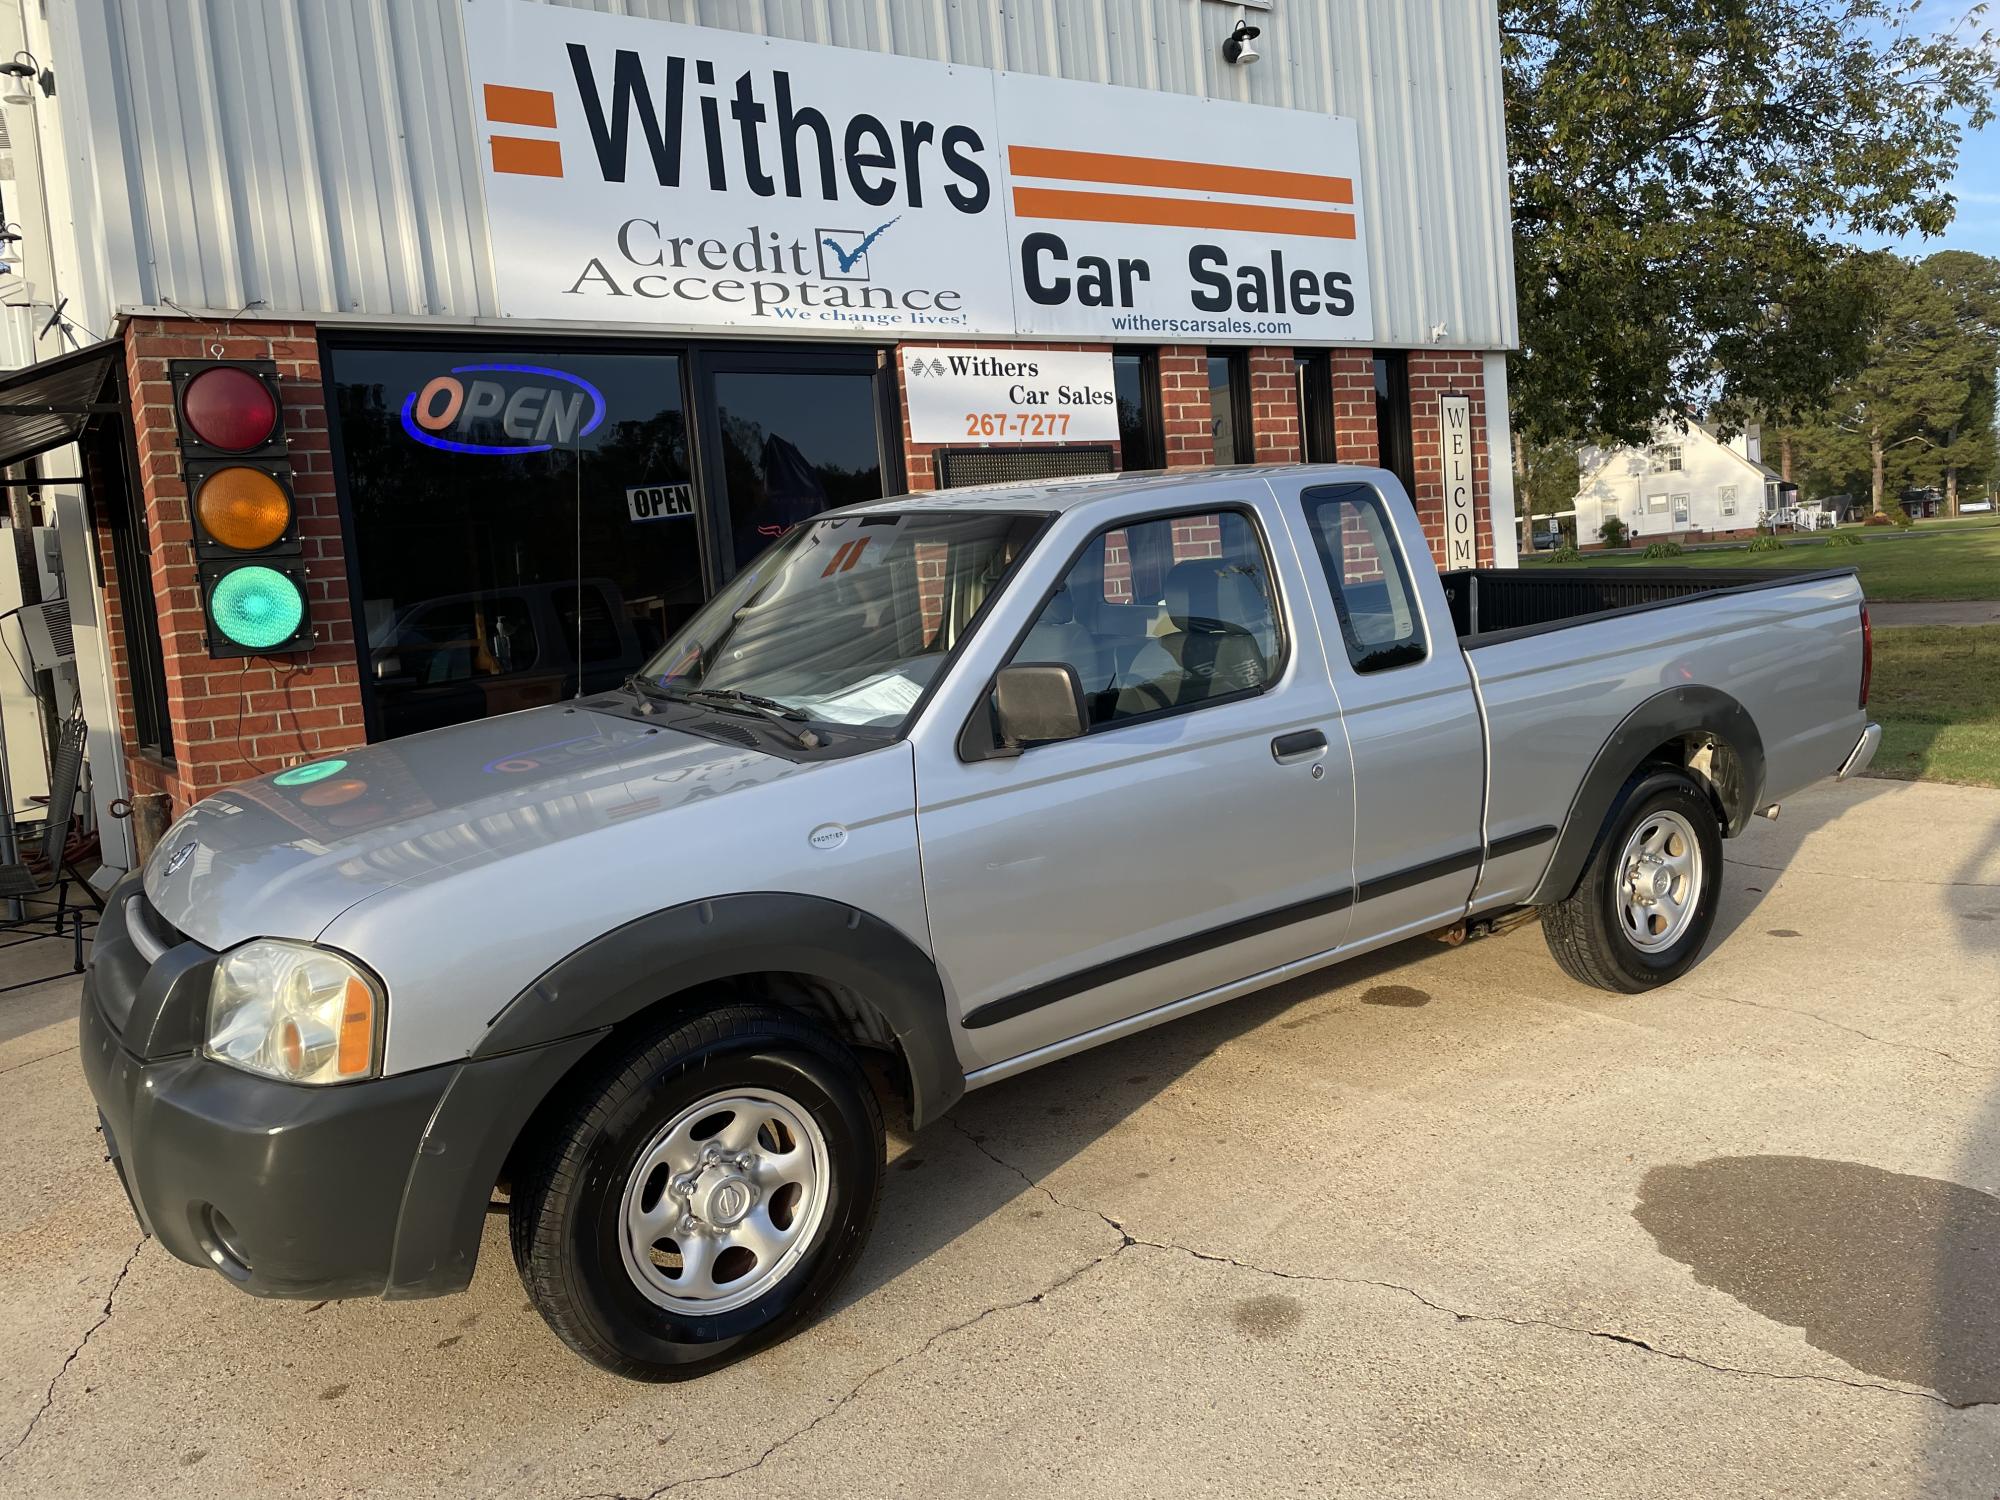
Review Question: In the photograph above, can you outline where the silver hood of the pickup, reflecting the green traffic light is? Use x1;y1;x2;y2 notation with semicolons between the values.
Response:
144;706;816;948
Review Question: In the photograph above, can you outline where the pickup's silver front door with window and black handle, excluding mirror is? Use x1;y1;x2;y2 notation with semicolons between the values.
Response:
914;490;1354;1064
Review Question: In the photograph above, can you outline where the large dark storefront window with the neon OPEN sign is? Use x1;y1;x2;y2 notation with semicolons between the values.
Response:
328;348;704;736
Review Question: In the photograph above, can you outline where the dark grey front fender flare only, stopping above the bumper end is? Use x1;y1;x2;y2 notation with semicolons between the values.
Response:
472;892;966;1126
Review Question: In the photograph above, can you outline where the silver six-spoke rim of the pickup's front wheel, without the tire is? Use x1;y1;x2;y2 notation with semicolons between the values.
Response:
620;1092;830;1314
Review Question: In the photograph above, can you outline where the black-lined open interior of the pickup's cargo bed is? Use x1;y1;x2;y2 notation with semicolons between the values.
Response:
1440;568;1854;646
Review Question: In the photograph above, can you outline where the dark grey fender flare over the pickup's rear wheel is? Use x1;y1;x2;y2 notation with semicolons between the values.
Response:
1526;686;1764;906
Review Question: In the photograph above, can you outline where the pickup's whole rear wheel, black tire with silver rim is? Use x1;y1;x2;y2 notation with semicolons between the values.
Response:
1542;772;1722;994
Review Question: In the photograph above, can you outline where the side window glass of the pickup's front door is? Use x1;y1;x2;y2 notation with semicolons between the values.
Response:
1012;510;1284;728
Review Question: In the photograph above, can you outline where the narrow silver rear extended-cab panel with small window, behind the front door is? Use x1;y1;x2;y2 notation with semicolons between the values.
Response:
1282;480;1486;944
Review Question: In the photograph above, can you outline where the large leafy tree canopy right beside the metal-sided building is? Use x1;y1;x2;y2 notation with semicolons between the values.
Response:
1500;0;2000;442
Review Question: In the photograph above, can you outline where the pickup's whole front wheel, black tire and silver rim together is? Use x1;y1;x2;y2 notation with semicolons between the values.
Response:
510;1004;884;1380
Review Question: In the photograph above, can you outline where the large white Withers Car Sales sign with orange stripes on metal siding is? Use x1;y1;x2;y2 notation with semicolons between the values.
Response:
464;0;1374;344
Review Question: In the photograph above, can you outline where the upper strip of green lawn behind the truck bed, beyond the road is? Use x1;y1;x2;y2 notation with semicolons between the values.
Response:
1522;518;2000;600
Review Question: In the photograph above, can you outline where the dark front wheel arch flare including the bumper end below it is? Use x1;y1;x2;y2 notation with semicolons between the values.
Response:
386;892;966;1298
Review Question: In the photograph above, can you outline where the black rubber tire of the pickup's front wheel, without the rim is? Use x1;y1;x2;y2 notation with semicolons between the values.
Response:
508;1004;886;1380
